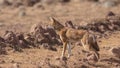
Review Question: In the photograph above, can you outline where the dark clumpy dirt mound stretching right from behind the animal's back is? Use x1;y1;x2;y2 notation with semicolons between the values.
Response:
78;11;120;36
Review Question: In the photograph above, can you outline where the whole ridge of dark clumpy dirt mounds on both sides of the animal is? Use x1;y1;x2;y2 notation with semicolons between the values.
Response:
0;11;120;54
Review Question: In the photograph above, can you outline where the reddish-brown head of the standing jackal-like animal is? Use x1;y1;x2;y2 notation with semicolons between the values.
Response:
50;17;64;31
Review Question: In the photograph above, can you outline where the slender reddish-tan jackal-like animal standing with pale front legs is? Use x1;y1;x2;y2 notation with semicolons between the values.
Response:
50;17;100;59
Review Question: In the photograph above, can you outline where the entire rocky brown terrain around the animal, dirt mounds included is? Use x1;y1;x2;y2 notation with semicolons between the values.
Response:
0;0;120;68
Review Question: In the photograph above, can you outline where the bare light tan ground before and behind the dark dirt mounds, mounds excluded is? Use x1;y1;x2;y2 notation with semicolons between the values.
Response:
0;2;120;68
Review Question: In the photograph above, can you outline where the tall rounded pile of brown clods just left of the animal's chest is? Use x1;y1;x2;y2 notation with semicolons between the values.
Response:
30;24;59;44
